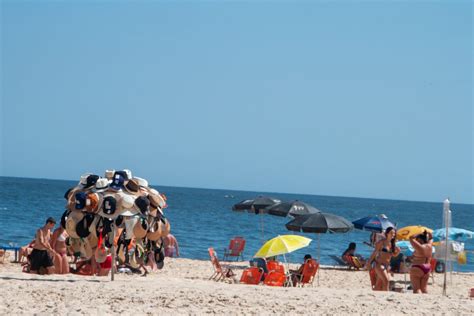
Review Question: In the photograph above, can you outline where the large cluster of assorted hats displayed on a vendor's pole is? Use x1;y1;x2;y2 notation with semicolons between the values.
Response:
61;169;170;267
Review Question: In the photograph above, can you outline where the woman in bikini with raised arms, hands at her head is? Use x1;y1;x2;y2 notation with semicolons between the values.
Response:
410;230;433;293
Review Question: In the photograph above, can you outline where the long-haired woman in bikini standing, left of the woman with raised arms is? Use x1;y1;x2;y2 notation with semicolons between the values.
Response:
367;227;400;291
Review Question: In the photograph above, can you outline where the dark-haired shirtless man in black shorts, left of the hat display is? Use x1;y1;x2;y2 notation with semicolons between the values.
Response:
30;217;56;274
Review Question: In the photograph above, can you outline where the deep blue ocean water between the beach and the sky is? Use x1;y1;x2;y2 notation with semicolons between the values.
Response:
0;177;474;272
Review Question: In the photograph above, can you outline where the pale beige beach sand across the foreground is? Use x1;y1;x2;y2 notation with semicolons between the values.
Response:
0;252;474;315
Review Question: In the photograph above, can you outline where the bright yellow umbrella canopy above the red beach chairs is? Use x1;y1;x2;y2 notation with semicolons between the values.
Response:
254;235;311;258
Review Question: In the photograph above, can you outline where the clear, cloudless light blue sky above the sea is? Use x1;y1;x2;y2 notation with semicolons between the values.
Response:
0;1;474;203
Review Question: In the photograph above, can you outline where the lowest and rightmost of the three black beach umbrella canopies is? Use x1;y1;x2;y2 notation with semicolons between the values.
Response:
286;212;353;234
